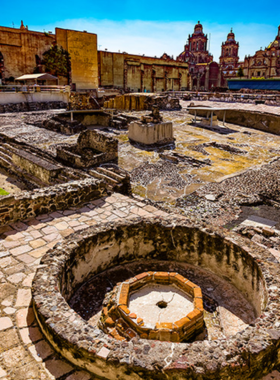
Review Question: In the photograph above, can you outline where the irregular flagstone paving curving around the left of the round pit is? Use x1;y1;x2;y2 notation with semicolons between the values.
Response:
0;194;167;380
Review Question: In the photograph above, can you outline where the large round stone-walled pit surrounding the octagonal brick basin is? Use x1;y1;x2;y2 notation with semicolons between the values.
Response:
32;215;280;380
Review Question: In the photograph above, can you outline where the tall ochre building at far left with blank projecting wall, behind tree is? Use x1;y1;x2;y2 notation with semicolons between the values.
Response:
0;22;98;89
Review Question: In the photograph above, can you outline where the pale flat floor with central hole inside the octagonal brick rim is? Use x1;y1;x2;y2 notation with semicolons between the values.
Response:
129;284;194;328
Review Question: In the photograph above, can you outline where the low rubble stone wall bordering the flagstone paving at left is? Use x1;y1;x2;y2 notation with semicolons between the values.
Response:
0;179;107;226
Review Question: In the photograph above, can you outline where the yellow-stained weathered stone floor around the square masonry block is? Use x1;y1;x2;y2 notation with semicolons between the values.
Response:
118;107;280;204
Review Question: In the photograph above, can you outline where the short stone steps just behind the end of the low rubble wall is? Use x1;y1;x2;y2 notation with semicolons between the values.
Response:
88;164;131;194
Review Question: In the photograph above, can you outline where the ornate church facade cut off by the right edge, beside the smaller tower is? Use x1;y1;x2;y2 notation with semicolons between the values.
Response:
244;25;280;78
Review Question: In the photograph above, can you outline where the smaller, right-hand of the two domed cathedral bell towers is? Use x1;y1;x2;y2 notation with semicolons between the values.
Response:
220;29;240;79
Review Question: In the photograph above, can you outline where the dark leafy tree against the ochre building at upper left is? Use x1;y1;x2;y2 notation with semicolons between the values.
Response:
42;45;71;80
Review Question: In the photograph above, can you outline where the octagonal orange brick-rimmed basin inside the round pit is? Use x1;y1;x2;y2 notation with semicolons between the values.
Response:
99;272;204;342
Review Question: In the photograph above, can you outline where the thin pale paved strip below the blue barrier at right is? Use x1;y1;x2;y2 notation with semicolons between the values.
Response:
180;100;280;115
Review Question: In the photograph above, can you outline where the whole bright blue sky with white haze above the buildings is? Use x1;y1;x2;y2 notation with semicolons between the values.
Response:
0;0;280;60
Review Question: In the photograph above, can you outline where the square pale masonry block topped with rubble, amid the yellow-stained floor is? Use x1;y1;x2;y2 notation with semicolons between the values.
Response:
128;106;175;145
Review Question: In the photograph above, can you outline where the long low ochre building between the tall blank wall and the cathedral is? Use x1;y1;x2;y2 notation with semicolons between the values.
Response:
98;51;189;92
